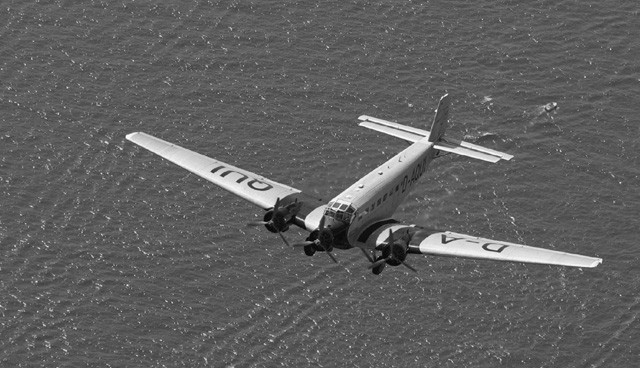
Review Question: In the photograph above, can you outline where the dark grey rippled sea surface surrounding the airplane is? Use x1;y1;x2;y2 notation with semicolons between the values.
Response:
0;0;640;367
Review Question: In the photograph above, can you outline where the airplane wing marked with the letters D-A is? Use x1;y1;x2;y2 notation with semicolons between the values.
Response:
409;231;602;268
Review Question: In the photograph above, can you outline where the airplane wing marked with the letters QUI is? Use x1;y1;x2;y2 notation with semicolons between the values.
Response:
127;132;300;209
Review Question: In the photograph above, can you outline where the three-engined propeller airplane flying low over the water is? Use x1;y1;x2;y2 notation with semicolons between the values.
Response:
126;94;602;275
